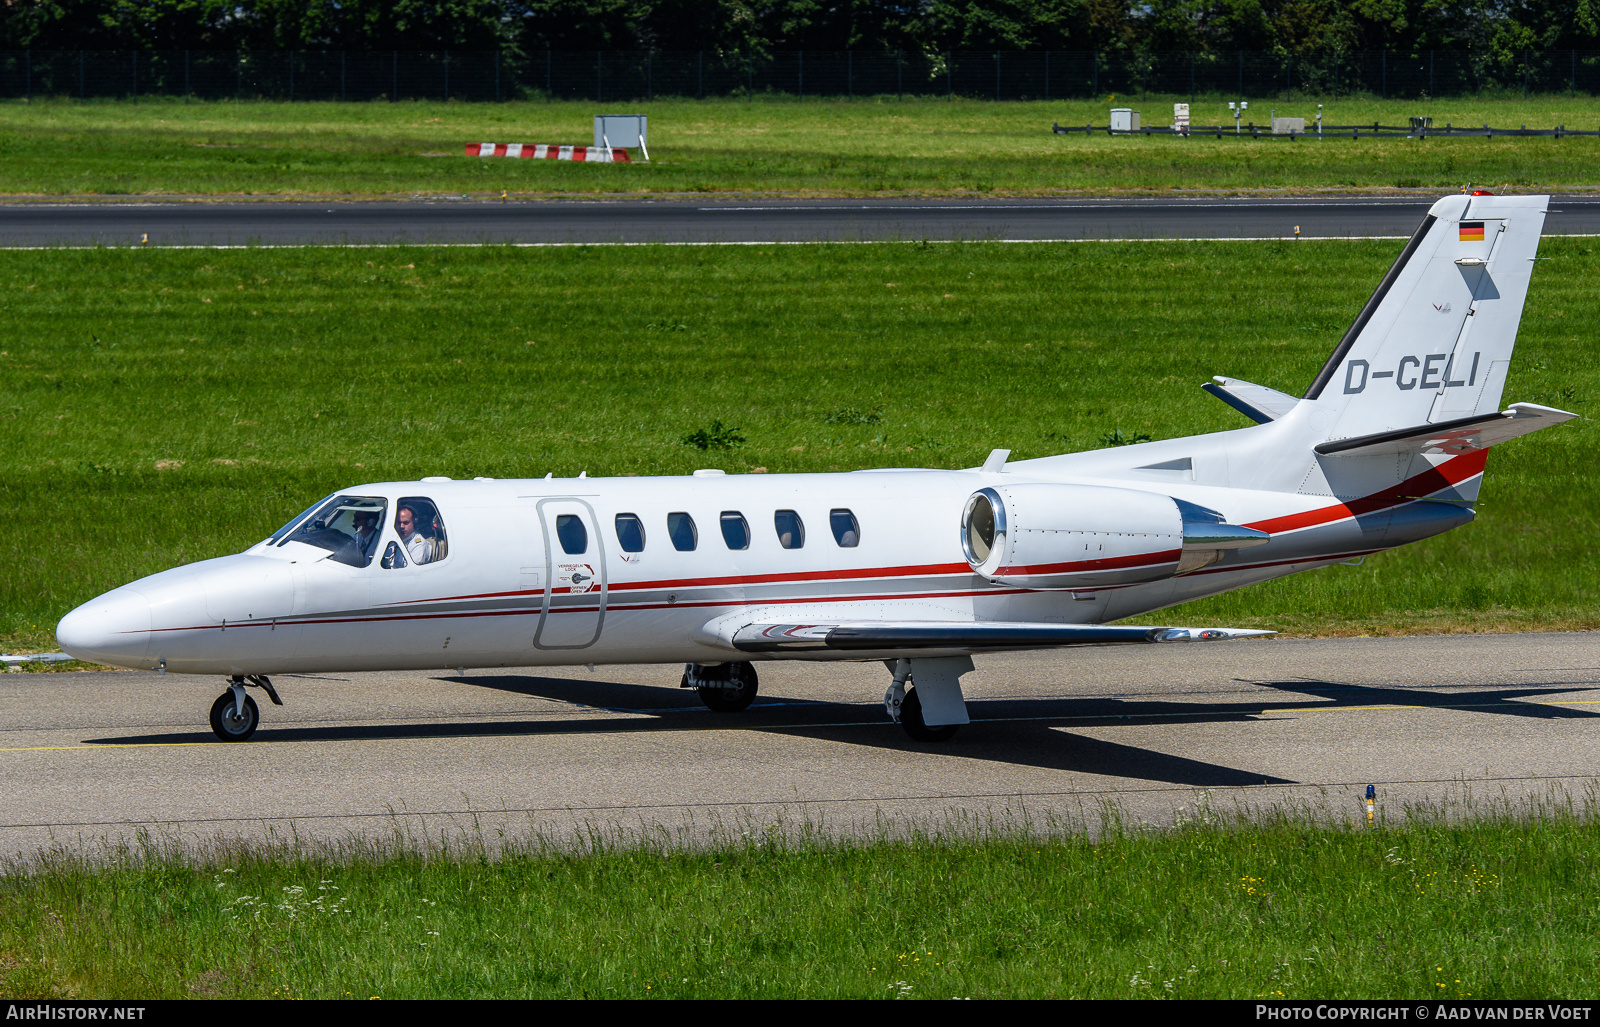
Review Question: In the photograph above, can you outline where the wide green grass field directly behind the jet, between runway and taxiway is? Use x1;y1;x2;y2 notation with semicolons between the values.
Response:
0;238;1600;651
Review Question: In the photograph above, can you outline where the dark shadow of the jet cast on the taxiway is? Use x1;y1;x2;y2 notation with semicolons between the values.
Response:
86;673;1600;787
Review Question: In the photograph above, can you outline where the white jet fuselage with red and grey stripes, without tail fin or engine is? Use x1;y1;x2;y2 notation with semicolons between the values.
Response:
58;429;1482;675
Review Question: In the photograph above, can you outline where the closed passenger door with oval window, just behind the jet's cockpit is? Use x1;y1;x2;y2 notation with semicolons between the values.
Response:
533;499;606;649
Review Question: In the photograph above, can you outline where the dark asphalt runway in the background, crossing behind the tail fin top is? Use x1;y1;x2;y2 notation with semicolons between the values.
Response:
9;194;1600;246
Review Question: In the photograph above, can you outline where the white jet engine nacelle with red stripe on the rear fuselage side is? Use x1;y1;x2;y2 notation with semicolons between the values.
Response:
962;485;1269;589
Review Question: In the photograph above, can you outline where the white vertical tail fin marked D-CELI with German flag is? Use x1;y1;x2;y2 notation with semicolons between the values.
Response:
1306;195;1549;440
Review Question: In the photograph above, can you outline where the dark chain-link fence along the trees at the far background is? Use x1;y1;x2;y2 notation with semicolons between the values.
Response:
9;50;1600;102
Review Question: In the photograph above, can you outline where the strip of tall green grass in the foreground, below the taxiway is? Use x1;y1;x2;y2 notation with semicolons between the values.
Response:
0;800;1600;1000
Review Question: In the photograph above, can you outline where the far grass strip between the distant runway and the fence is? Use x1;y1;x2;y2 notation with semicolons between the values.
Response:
9;96;1600;197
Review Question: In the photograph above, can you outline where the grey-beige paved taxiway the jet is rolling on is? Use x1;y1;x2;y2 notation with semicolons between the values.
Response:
0;632;1600;856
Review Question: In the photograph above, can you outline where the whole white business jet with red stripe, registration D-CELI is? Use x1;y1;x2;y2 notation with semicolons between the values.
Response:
56;194;1576;741
